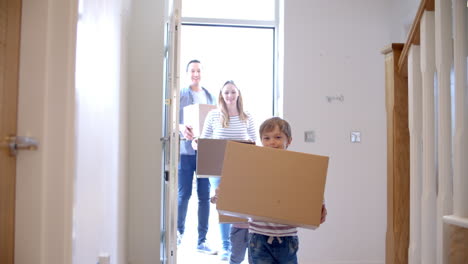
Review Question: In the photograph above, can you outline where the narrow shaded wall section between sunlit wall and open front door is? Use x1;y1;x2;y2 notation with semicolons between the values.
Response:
127;0;165;264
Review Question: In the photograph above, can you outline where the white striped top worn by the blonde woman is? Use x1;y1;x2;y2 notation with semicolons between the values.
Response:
200;109;257;141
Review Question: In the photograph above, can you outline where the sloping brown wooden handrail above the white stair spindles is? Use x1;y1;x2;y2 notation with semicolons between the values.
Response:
398;0;435;76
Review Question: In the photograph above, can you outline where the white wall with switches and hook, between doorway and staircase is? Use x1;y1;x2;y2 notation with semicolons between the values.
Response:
284;0;392;264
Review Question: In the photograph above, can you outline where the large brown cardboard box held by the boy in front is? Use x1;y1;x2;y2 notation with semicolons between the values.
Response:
216;142;329;229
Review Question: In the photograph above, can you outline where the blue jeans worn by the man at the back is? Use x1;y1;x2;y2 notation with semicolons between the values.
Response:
177;155;210;244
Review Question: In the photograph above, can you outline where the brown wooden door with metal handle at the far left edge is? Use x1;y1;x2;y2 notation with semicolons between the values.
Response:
0;0;21;264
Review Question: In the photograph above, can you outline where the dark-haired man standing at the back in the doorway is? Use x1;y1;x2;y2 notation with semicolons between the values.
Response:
177;60;217;254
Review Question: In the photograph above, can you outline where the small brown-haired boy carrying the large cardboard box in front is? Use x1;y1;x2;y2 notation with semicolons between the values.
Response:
249;117;327;264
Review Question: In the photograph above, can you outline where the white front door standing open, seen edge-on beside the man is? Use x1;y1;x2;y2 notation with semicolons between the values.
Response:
161;0;181;263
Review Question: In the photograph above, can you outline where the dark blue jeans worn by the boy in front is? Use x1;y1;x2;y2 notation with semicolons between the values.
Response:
249;234;299;264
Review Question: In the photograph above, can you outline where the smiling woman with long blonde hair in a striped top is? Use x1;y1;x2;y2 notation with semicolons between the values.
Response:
200;81;257;263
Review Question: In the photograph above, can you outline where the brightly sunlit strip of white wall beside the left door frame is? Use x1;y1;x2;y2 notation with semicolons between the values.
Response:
73;0;129;264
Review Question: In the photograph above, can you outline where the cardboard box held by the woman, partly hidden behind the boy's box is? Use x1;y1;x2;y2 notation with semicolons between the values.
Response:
197;138;255;178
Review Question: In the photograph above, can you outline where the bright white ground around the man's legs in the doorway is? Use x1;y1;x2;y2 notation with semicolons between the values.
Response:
177;177;248;264
